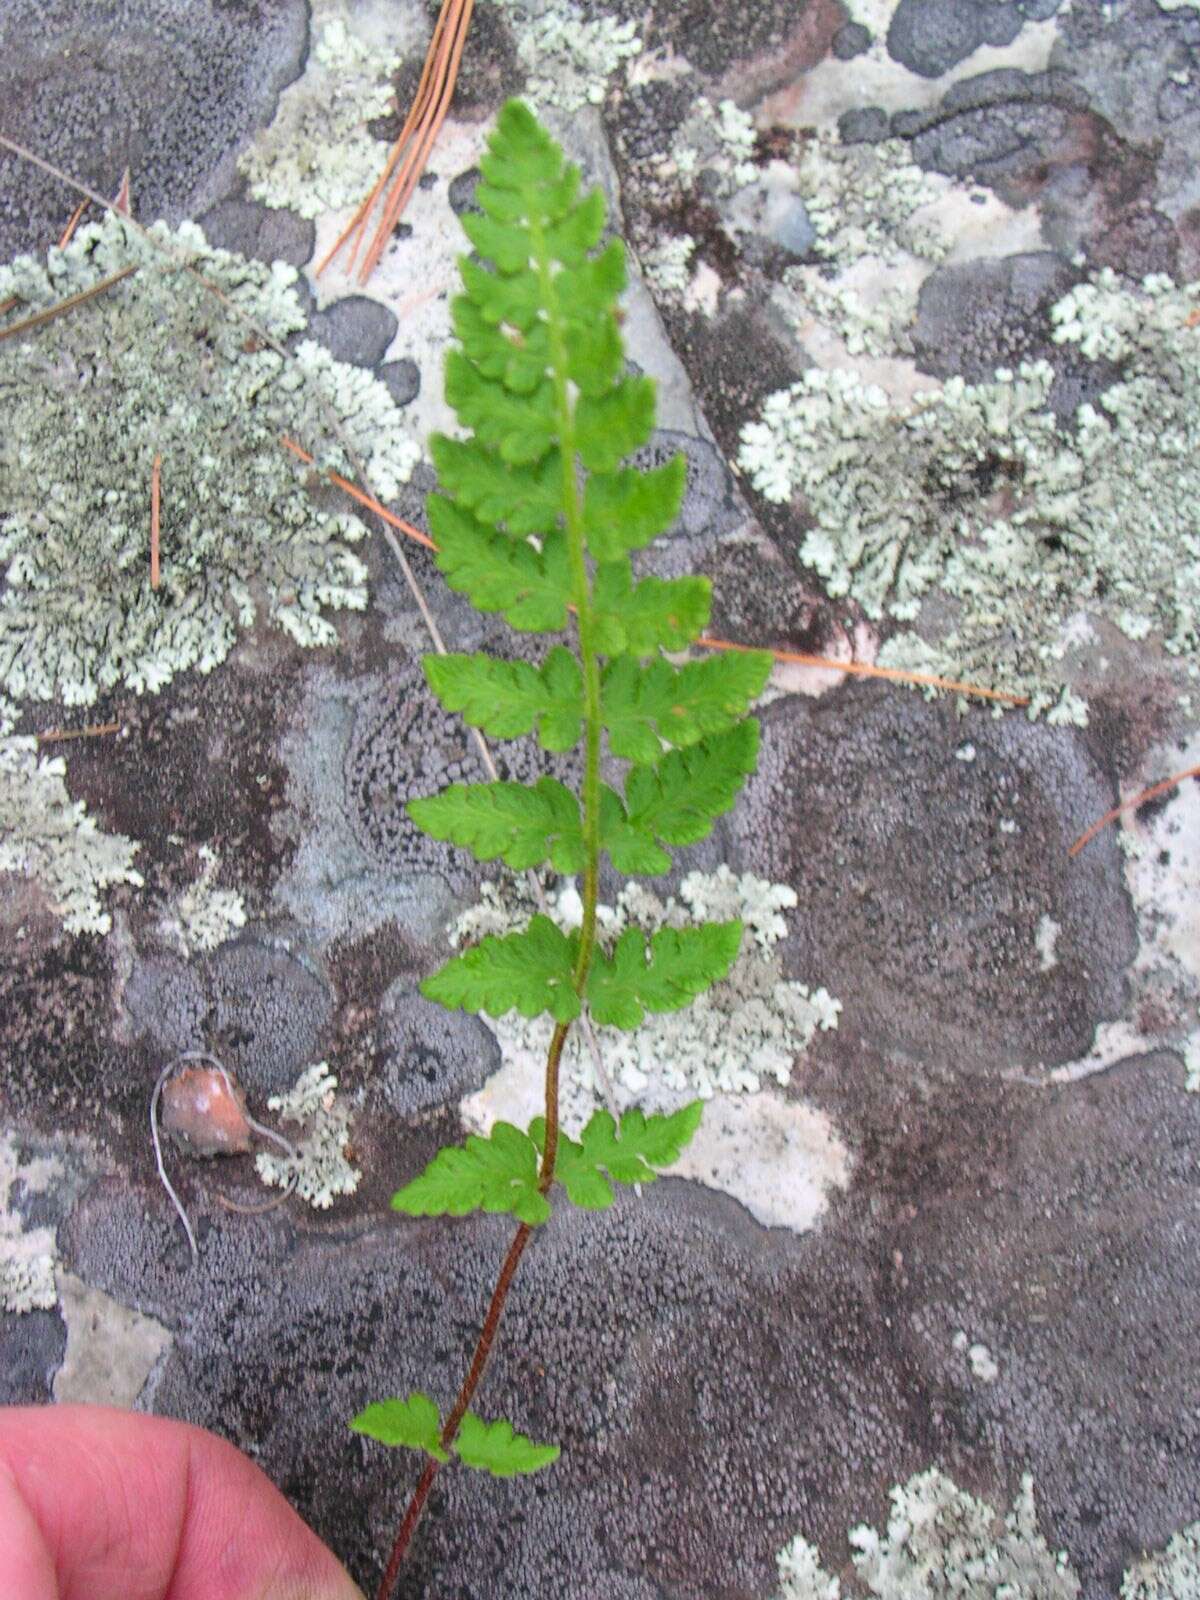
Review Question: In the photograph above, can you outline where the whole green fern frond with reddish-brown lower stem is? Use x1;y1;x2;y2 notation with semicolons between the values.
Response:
350;101;770;1600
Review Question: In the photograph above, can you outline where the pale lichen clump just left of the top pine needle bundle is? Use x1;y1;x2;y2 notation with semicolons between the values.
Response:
238;16;400;218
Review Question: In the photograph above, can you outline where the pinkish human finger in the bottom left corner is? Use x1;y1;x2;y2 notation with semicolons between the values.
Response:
0;1405;362;1600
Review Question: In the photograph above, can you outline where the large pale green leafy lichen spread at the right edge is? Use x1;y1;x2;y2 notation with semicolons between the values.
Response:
739;274;1200;722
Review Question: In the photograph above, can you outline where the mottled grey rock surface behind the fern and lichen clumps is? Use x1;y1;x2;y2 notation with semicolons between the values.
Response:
0;0;1200;1600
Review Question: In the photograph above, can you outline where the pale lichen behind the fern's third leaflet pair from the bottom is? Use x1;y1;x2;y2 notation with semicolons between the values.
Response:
451;866;842;1123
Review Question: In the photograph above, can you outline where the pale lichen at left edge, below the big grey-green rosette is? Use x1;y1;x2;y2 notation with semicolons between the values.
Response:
0;698;142;933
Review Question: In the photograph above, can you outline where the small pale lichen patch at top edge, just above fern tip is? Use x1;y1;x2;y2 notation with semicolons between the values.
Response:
499;0;642;112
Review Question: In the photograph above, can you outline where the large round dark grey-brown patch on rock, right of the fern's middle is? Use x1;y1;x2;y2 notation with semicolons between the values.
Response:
744;686;1134;1072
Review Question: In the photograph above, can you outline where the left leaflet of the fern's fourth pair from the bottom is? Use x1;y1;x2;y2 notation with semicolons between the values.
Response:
408;778;587;872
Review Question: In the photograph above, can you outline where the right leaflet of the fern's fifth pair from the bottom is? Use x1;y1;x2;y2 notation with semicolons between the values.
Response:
600;650;771;762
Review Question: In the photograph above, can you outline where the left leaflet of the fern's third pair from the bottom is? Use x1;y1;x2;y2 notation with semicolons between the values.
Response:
421;917;579;1022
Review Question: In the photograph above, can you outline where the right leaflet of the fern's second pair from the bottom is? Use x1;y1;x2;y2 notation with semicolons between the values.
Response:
530;1101;704;1211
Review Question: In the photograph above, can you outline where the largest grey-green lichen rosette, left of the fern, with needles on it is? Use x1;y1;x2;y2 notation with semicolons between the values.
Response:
0;218;418;704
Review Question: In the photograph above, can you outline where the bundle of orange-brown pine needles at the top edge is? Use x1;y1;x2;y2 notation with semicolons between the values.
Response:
317;0;475;283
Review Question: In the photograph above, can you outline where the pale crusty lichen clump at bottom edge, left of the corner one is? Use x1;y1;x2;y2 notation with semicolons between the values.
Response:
778;1467;1080;1600
